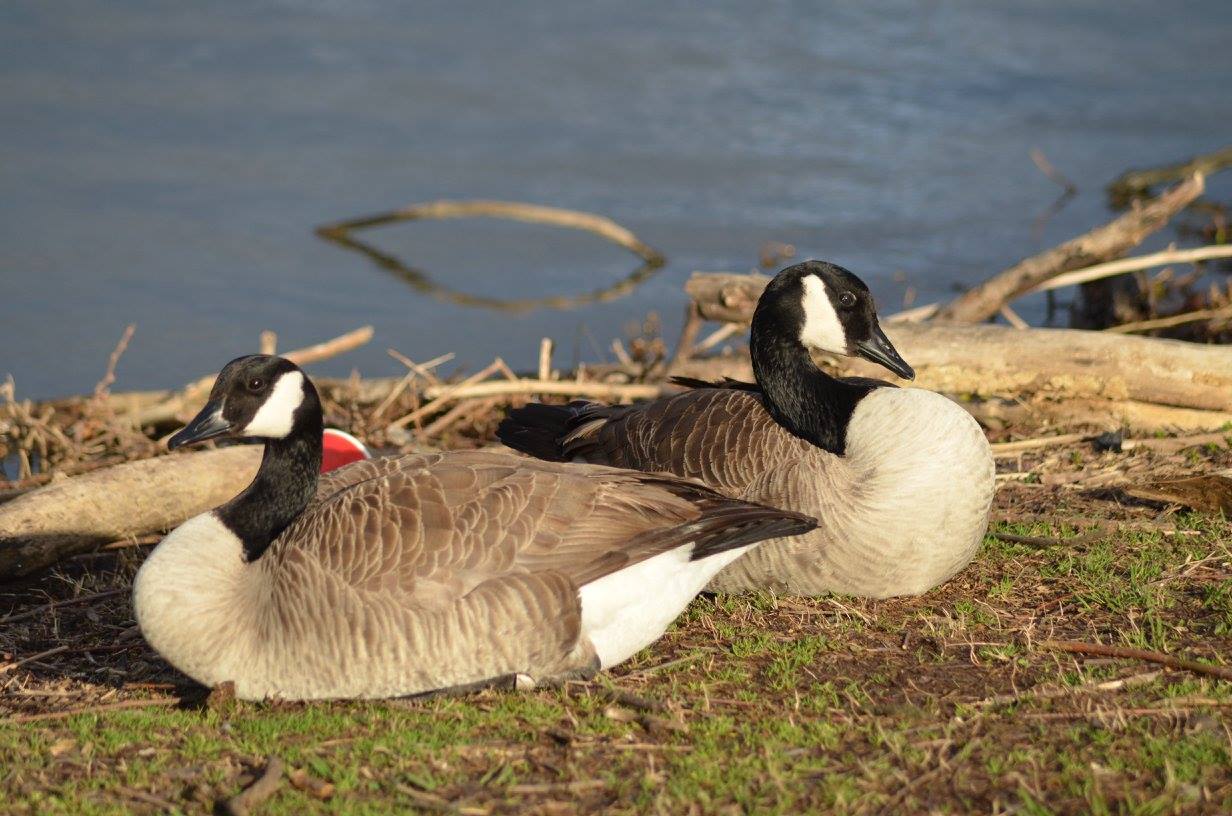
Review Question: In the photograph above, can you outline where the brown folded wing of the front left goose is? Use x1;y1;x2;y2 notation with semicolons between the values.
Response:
266;451;813;609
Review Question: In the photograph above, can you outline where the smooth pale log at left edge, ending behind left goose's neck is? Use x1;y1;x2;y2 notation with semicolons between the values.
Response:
0;445;261;579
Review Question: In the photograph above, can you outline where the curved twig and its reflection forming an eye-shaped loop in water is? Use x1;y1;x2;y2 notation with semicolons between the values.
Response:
317;198;664;312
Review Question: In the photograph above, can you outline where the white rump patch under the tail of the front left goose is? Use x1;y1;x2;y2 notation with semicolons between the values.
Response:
578;544;753;668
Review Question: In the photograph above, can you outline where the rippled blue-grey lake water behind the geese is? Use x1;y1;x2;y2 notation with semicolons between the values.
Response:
0;0;1232;397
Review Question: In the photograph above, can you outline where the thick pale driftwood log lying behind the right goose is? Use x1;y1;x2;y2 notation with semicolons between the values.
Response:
673;272;1232;430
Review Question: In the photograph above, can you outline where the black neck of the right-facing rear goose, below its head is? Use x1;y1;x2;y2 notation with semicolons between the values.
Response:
749;318;872;456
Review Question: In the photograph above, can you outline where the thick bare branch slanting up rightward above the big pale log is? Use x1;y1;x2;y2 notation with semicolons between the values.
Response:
935;175;1205;323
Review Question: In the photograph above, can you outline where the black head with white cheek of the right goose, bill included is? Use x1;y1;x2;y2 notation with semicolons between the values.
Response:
752;260;915;380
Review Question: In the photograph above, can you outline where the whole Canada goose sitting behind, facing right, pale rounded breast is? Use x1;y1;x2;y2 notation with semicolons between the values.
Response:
496;260;994;598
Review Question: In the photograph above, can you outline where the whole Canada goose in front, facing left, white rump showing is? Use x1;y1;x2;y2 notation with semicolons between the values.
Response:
133;355;814;699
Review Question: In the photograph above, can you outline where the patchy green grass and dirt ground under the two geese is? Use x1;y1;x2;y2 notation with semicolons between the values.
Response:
0;507;1232;815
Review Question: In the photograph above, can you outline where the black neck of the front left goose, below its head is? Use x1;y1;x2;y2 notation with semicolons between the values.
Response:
217;383;324;561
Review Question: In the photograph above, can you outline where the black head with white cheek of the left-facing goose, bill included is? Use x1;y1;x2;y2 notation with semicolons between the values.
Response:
168;354;320;450
